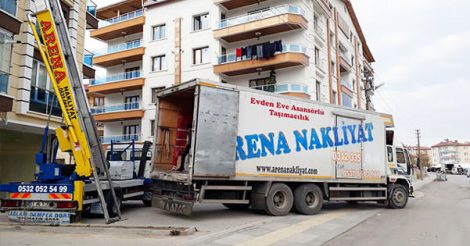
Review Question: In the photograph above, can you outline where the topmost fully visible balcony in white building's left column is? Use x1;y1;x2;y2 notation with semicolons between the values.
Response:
90;9;145;41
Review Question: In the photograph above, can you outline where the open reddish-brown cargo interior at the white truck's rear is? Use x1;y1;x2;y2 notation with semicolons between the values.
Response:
152;87;195;179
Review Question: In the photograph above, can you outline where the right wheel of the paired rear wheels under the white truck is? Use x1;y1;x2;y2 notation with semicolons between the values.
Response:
294;184;323;215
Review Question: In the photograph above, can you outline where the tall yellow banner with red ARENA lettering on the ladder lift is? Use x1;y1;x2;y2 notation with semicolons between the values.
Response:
36;10;92;177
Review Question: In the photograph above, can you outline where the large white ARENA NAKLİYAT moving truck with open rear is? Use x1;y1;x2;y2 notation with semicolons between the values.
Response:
151;80;413;215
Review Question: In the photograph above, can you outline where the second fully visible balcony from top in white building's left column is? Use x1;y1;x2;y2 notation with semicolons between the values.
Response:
93;40;145;67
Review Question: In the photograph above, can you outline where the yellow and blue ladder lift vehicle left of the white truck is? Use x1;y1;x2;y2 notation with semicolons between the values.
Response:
0;0;151;224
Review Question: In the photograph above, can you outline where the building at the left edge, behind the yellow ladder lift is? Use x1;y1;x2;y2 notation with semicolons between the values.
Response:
0;0;98;183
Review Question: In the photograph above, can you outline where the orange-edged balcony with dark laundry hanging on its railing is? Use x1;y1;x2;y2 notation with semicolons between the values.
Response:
214;44;309;76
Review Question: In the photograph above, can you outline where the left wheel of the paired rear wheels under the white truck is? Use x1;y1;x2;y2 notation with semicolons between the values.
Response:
264;183;294;216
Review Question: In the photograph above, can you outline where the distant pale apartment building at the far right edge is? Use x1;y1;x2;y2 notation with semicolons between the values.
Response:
431;139;470;165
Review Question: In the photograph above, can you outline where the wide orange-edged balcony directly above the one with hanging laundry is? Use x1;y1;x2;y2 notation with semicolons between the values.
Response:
214;5;307;43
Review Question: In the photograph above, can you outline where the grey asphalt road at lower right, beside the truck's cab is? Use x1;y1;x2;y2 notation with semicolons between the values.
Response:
325;175;470;246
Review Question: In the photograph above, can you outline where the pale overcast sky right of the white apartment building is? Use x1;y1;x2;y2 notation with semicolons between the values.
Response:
87;0;470;146
